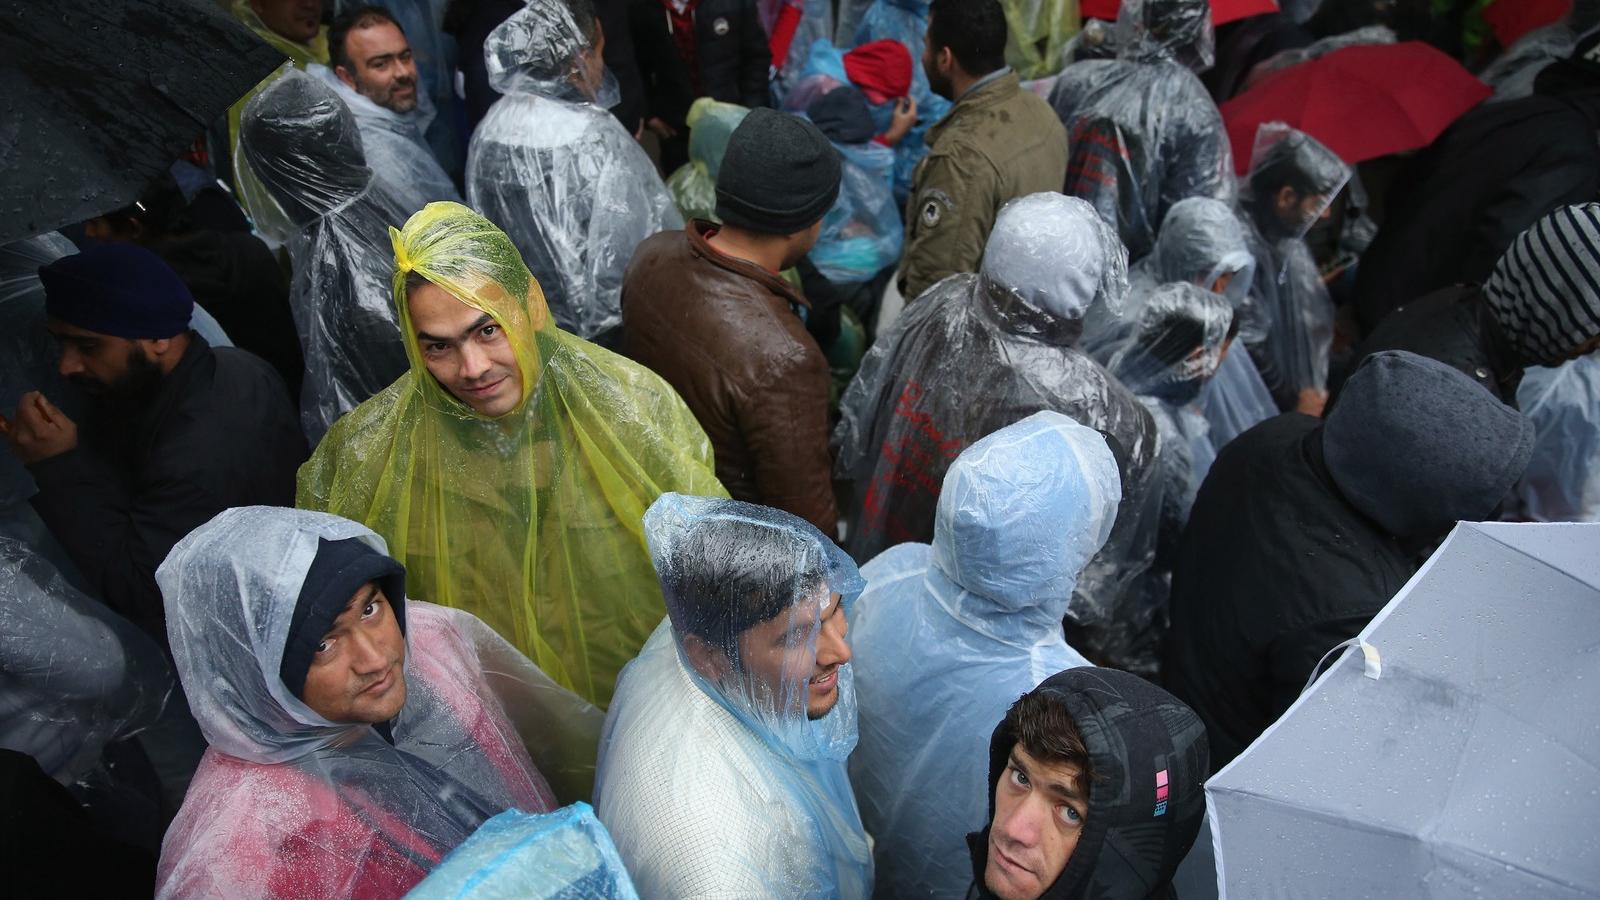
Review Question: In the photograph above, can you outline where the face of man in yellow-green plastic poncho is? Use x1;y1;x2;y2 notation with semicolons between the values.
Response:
408;283;522;418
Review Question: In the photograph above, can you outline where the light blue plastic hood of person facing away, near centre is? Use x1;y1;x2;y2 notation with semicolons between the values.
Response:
933;412;1122;628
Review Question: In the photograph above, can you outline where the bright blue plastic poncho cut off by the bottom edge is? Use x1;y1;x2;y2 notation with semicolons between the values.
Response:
406;801;638;900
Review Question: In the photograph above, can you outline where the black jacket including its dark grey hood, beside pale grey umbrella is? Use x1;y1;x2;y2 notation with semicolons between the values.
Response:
1165;352;1533;767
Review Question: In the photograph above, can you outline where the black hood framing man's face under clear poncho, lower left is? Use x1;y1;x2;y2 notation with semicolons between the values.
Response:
278;538;405;700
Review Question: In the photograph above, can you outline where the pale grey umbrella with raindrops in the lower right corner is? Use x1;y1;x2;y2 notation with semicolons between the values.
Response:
1206;524;1600;898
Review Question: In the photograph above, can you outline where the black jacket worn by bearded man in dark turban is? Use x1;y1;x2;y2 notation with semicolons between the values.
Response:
30;333;306;647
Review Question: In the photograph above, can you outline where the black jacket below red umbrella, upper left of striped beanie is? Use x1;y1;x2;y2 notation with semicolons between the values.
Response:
1355;90;1600;333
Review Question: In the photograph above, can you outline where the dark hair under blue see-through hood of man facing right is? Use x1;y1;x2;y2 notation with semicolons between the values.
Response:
656;519;826;660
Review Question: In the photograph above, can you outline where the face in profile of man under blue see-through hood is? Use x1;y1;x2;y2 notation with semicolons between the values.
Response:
739;594;850;719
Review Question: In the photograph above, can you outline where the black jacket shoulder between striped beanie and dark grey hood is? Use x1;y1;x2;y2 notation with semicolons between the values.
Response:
1330;285;1525;408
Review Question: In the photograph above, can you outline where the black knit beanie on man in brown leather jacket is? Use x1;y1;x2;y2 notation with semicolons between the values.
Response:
717;109;840;234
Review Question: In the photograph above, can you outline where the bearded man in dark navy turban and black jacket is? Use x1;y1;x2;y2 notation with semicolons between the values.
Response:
0;243;306;647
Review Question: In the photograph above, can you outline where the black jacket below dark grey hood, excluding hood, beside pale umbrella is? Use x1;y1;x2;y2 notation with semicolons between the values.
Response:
1165;413;1414;769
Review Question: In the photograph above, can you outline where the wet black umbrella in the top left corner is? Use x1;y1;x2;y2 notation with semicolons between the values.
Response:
0;0;283;243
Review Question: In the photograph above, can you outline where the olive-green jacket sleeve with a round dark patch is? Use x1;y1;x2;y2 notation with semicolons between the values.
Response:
899;151;998;303
